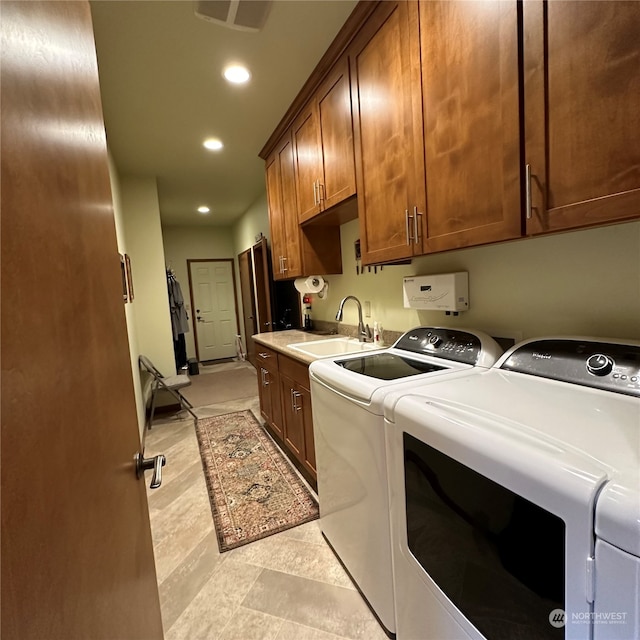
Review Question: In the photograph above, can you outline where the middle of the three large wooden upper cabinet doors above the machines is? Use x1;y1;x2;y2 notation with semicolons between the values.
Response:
419;0;522;252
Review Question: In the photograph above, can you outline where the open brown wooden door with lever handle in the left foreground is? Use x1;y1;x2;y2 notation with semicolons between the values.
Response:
1;0;165;640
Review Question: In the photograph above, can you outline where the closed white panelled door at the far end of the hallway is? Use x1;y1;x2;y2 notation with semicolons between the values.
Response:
188;260;238;361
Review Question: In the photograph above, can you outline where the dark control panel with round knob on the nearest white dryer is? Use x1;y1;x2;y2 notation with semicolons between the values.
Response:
500;339;640;397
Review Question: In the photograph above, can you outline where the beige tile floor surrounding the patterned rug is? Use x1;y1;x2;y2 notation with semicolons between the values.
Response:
146;362;386;640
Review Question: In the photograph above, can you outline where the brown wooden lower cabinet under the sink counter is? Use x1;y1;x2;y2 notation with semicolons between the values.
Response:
257;345;317;489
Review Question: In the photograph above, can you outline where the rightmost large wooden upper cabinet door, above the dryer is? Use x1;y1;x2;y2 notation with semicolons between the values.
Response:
523;0;640;234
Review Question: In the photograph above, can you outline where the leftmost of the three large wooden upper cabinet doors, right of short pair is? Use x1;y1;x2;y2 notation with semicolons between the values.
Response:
349;1;424;264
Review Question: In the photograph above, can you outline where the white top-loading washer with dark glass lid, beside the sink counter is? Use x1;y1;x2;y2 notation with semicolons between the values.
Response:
309;327;502;637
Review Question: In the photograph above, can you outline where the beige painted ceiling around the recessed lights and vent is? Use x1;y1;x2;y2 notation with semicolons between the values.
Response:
91;0;357;226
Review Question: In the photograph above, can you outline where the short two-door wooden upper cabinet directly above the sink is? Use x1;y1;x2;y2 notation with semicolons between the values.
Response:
293;58;356;222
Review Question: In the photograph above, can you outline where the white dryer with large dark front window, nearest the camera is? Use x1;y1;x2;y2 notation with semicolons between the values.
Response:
385;338;640;640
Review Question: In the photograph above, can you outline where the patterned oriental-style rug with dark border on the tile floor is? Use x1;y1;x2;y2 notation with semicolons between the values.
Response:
196;411;319;552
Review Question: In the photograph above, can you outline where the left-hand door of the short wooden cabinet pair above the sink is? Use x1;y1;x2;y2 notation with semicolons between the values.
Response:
291;105;322;222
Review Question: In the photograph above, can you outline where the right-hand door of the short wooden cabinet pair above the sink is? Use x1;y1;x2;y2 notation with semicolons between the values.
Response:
317;56;356;209
